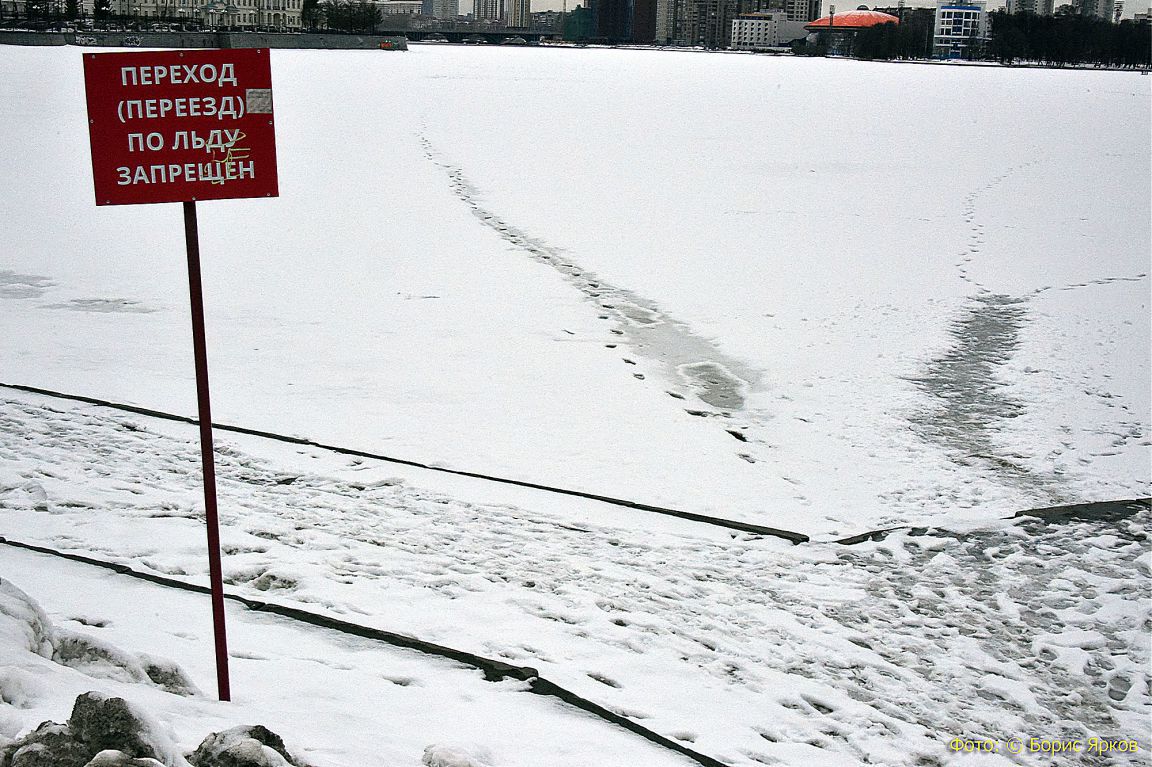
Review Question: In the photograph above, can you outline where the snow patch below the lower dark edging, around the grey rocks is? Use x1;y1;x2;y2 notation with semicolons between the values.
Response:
0;532;691;767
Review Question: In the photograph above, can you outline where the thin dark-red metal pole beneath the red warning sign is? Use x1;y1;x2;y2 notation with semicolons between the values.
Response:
184;202;232;700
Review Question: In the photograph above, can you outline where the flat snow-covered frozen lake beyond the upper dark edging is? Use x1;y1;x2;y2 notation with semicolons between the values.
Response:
0;46;1150;537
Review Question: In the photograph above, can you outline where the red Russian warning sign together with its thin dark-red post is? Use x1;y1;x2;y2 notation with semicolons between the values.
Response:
84;48;279;700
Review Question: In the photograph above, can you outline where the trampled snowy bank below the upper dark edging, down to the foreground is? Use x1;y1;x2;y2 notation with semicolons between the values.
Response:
0;396;1152;767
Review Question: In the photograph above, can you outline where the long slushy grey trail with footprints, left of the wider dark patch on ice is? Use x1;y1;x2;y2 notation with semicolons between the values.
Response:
418;134;760;463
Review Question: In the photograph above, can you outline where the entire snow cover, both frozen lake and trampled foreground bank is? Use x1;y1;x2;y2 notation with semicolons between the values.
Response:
0;46;1152;767
